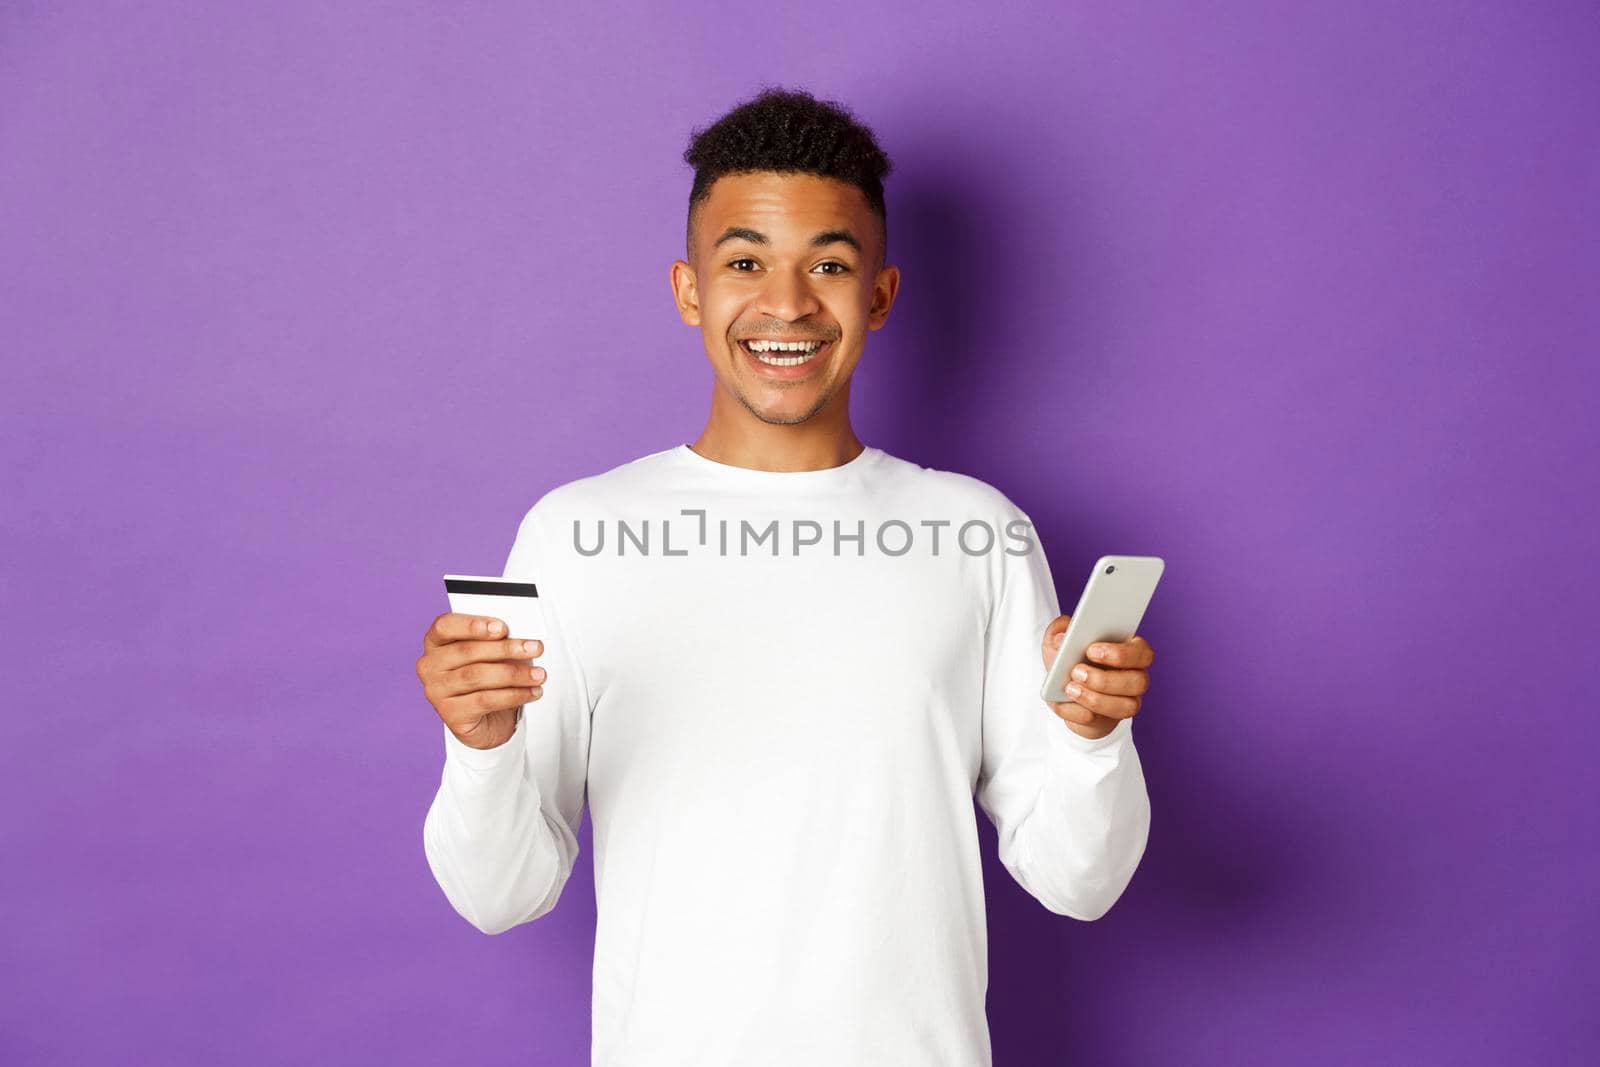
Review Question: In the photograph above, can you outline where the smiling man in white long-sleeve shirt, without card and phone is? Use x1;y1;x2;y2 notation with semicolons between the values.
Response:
418;90;1152;1067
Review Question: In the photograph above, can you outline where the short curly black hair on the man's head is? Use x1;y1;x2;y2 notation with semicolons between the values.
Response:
683;86;894;268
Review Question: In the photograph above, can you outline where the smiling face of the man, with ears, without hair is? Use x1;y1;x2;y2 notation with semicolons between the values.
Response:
672;171;899;424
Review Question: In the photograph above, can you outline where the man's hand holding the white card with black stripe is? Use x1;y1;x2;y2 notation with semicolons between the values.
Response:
416;611;546;749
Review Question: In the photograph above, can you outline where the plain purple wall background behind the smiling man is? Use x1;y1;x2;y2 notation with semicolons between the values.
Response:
0;0;1600;1067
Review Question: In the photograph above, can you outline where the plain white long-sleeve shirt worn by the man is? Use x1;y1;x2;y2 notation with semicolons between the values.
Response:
424;445;1150;1067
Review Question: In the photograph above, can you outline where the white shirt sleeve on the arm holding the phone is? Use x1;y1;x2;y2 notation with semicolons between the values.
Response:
978;510;1150;920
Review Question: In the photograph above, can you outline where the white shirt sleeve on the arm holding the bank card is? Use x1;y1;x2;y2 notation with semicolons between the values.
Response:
422;504;590;934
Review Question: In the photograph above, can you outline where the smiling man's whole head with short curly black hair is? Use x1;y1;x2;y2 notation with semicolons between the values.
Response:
672;90;899;424
